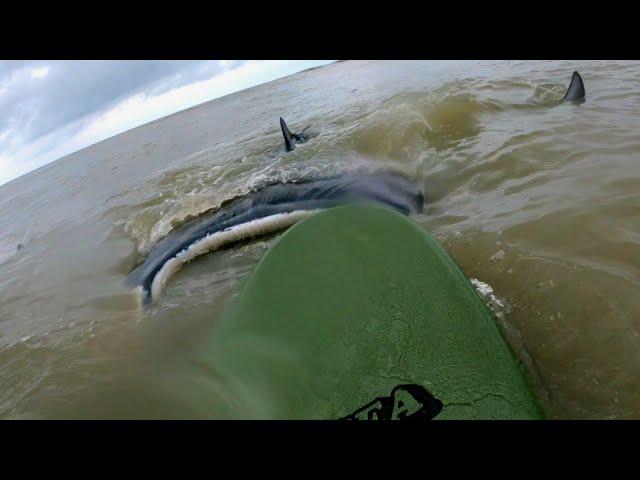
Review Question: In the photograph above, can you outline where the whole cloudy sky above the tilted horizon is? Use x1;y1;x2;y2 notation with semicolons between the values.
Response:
0;60;338;185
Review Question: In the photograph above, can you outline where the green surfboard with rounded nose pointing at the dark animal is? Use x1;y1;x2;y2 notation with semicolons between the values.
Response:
168;206;542;419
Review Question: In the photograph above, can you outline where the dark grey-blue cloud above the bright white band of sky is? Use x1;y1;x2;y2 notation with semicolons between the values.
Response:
0;60;241;151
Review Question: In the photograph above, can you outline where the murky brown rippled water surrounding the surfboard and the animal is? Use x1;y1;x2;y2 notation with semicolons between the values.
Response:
0;61;640;418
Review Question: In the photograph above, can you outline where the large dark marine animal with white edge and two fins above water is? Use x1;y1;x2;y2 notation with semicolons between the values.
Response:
126;72;585;303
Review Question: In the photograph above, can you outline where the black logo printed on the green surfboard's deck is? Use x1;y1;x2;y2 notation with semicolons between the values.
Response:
341;384;442;420
